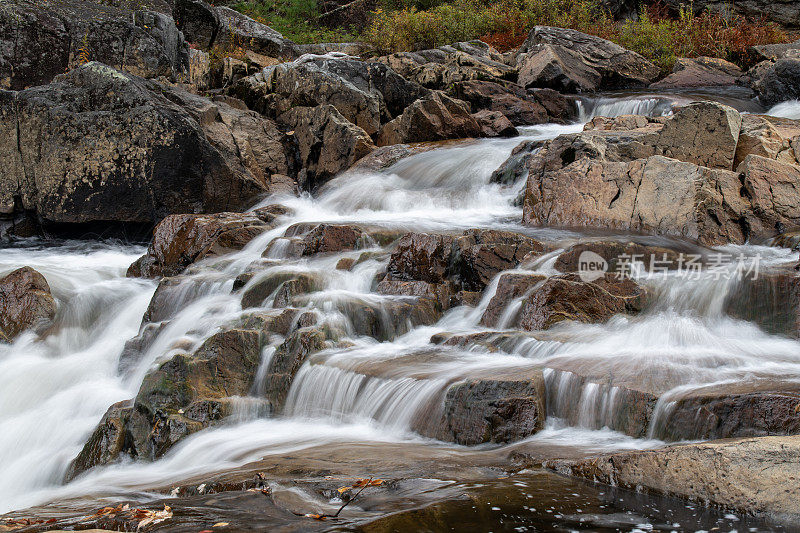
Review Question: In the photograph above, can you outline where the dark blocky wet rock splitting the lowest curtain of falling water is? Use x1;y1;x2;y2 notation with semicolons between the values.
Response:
436;372;545;446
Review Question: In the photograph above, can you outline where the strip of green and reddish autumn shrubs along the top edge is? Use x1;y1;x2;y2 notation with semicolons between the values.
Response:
228;0;790;73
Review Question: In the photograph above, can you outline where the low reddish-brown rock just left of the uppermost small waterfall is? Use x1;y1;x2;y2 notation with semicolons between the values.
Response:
448;80;549;126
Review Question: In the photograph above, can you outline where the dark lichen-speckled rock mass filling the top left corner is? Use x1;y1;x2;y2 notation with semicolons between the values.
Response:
0;0;189;89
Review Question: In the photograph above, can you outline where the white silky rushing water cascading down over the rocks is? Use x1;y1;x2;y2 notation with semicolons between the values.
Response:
0;95;800;524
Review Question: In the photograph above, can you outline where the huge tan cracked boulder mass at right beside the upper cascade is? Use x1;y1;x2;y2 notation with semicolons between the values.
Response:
509;102;800;244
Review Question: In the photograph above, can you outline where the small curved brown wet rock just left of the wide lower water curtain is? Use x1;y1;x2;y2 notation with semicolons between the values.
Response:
264;327;327;412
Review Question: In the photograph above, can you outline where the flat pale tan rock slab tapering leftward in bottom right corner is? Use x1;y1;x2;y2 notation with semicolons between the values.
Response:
546;436;800;521
